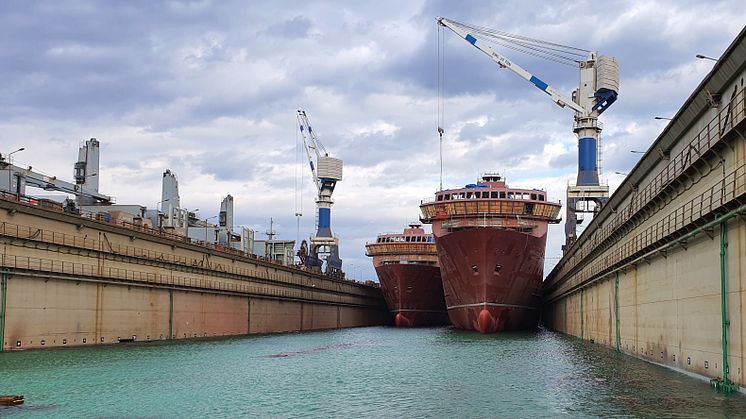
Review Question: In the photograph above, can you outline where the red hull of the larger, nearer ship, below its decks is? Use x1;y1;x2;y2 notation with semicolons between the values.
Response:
436;228;546;333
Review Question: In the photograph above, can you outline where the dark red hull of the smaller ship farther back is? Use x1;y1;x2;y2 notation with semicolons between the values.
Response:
376;263;448;327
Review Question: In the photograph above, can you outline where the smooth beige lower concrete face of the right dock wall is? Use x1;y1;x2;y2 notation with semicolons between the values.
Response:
544;219;746;387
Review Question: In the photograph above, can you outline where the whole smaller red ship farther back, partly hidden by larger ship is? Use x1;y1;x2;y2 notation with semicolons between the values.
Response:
365;223;448;327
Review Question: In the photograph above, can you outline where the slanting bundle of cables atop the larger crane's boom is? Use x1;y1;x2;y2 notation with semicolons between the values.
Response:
442;20;590;67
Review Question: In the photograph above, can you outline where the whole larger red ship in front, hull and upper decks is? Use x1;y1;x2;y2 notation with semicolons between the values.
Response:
420;173;561;333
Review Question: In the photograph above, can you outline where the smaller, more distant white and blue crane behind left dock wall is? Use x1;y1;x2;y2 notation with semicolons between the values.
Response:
298;110;344;277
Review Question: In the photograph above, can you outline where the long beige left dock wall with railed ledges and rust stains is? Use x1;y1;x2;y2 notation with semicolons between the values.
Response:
0;194;387;350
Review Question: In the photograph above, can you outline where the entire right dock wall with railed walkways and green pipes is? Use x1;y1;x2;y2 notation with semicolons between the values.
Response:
544;30;746;390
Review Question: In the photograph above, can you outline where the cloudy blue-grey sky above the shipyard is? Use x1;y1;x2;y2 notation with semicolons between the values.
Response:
0;0;746;279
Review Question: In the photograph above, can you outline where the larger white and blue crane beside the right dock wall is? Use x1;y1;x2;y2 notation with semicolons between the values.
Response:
437;17;619;250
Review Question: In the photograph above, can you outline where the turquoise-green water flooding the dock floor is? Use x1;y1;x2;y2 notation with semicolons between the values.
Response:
0;327;746;418
